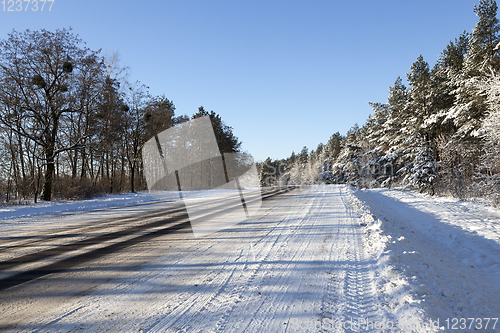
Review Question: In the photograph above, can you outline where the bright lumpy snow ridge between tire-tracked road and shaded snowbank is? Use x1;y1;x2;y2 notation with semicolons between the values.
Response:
348;187;433;332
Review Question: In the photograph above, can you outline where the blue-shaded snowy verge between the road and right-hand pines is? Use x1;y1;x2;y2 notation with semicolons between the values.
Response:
352;185;500;332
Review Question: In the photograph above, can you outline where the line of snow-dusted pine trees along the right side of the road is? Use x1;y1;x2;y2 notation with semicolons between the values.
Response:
261;0;500;204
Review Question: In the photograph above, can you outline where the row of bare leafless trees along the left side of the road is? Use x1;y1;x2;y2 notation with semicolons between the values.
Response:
0;29;241;202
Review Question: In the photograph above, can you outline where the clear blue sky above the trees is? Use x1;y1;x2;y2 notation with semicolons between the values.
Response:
0;0;478;160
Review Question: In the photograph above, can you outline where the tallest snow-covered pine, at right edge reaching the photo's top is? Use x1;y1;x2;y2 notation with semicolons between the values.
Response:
441;0;500;196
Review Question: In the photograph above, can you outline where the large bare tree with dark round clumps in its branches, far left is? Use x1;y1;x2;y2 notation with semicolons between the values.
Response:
0;29;105;200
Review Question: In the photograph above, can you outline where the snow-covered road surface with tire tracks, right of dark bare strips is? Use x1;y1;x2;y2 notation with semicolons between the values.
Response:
0;187;382;332
